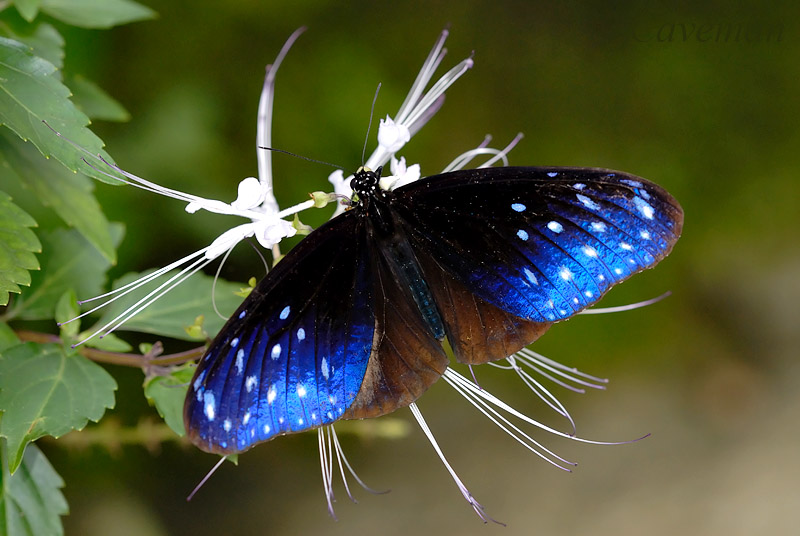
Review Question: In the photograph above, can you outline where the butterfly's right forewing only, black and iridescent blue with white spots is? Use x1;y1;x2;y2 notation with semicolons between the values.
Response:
393;167;683;355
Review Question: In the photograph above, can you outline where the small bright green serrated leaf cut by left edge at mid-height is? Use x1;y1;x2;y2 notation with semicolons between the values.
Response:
0;191;42;305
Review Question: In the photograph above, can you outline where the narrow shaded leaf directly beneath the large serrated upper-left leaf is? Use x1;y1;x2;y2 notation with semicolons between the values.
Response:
0;132;117;264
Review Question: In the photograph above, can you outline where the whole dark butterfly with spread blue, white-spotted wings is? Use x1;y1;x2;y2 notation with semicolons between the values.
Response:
184;167;683;454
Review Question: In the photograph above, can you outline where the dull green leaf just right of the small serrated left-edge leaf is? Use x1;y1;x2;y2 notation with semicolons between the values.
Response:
12;223;123;320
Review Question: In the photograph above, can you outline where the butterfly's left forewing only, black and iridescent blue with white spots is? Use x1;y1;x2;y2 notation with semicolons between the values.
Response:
184;213;376;454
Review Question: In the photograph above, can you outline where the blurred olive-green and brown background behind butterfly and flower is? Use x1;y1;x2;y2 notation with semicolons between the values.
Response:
43;0;800;536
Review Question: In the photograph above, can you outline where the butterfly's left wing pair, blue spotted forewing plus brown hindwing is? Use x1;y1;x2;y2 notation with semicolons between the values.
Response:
184;211;454;454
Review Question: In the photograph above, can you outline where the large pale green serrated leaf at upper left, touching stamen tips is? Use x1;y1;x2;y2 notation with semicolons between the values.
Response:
0;37;118;184
